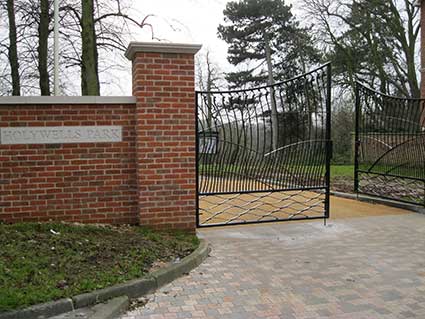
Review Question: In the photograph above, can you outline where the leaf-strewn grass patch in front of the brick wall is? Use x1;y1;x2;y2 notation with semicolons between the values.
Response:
0;223;199;312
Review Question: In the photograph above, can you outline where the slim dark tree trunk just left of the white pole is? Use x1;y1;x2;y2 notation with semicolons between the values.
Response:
38;0;50;95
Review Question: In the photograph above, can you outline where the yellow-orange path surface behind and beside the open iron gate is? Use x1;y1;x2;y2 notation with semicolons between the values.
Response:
199;192;410;228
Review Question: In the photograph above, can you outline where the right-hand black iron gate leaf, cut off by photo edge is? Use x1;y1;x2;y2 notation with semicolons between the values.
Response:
355;83;425;205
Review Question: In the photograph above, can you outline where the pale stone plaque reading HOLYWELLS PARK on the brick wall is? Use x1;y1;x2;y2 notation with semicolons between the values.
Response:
0;126;122;145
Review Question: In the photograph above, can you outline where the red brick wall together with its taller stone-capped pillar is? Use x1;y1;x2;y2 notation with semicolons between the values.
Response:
0;43;200;231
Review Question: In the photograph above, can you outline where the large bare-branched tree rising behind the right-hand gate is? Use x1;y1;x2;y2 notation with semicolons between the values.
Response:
303;0;420;97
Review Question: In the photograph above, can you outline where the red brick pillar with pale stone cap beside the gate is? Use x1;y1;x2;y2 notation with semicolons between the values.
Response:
126;42;201;231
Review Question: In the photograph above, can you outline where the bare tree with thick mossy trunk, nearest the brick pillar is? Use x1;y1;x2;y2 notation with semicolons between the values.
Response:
61;0;154;95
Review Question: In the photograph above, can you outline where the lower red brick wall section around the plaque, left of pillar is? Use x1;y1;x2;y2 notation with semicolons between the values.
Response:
0;104;138;224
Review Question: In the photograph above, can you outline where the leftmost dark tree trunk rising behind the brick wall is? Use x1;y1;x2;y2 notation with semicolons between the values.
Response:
7;0;21;96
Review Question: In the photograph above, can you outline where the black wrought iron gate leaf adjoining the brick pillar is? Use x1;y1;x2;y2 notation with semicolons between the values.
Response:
196;64;332;227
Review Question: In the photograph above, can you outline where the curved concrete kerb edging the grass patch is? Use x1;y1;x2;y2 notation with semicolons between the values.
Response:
0;239;211;319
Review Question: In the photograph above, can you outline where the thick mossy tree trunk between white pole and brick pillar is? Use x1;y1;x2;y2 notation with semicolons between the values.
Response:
81;0;100;95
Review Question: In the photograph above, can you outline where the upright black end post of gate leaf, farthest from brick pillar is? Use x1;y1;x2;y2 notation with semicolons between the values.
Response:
325;63;332;219
